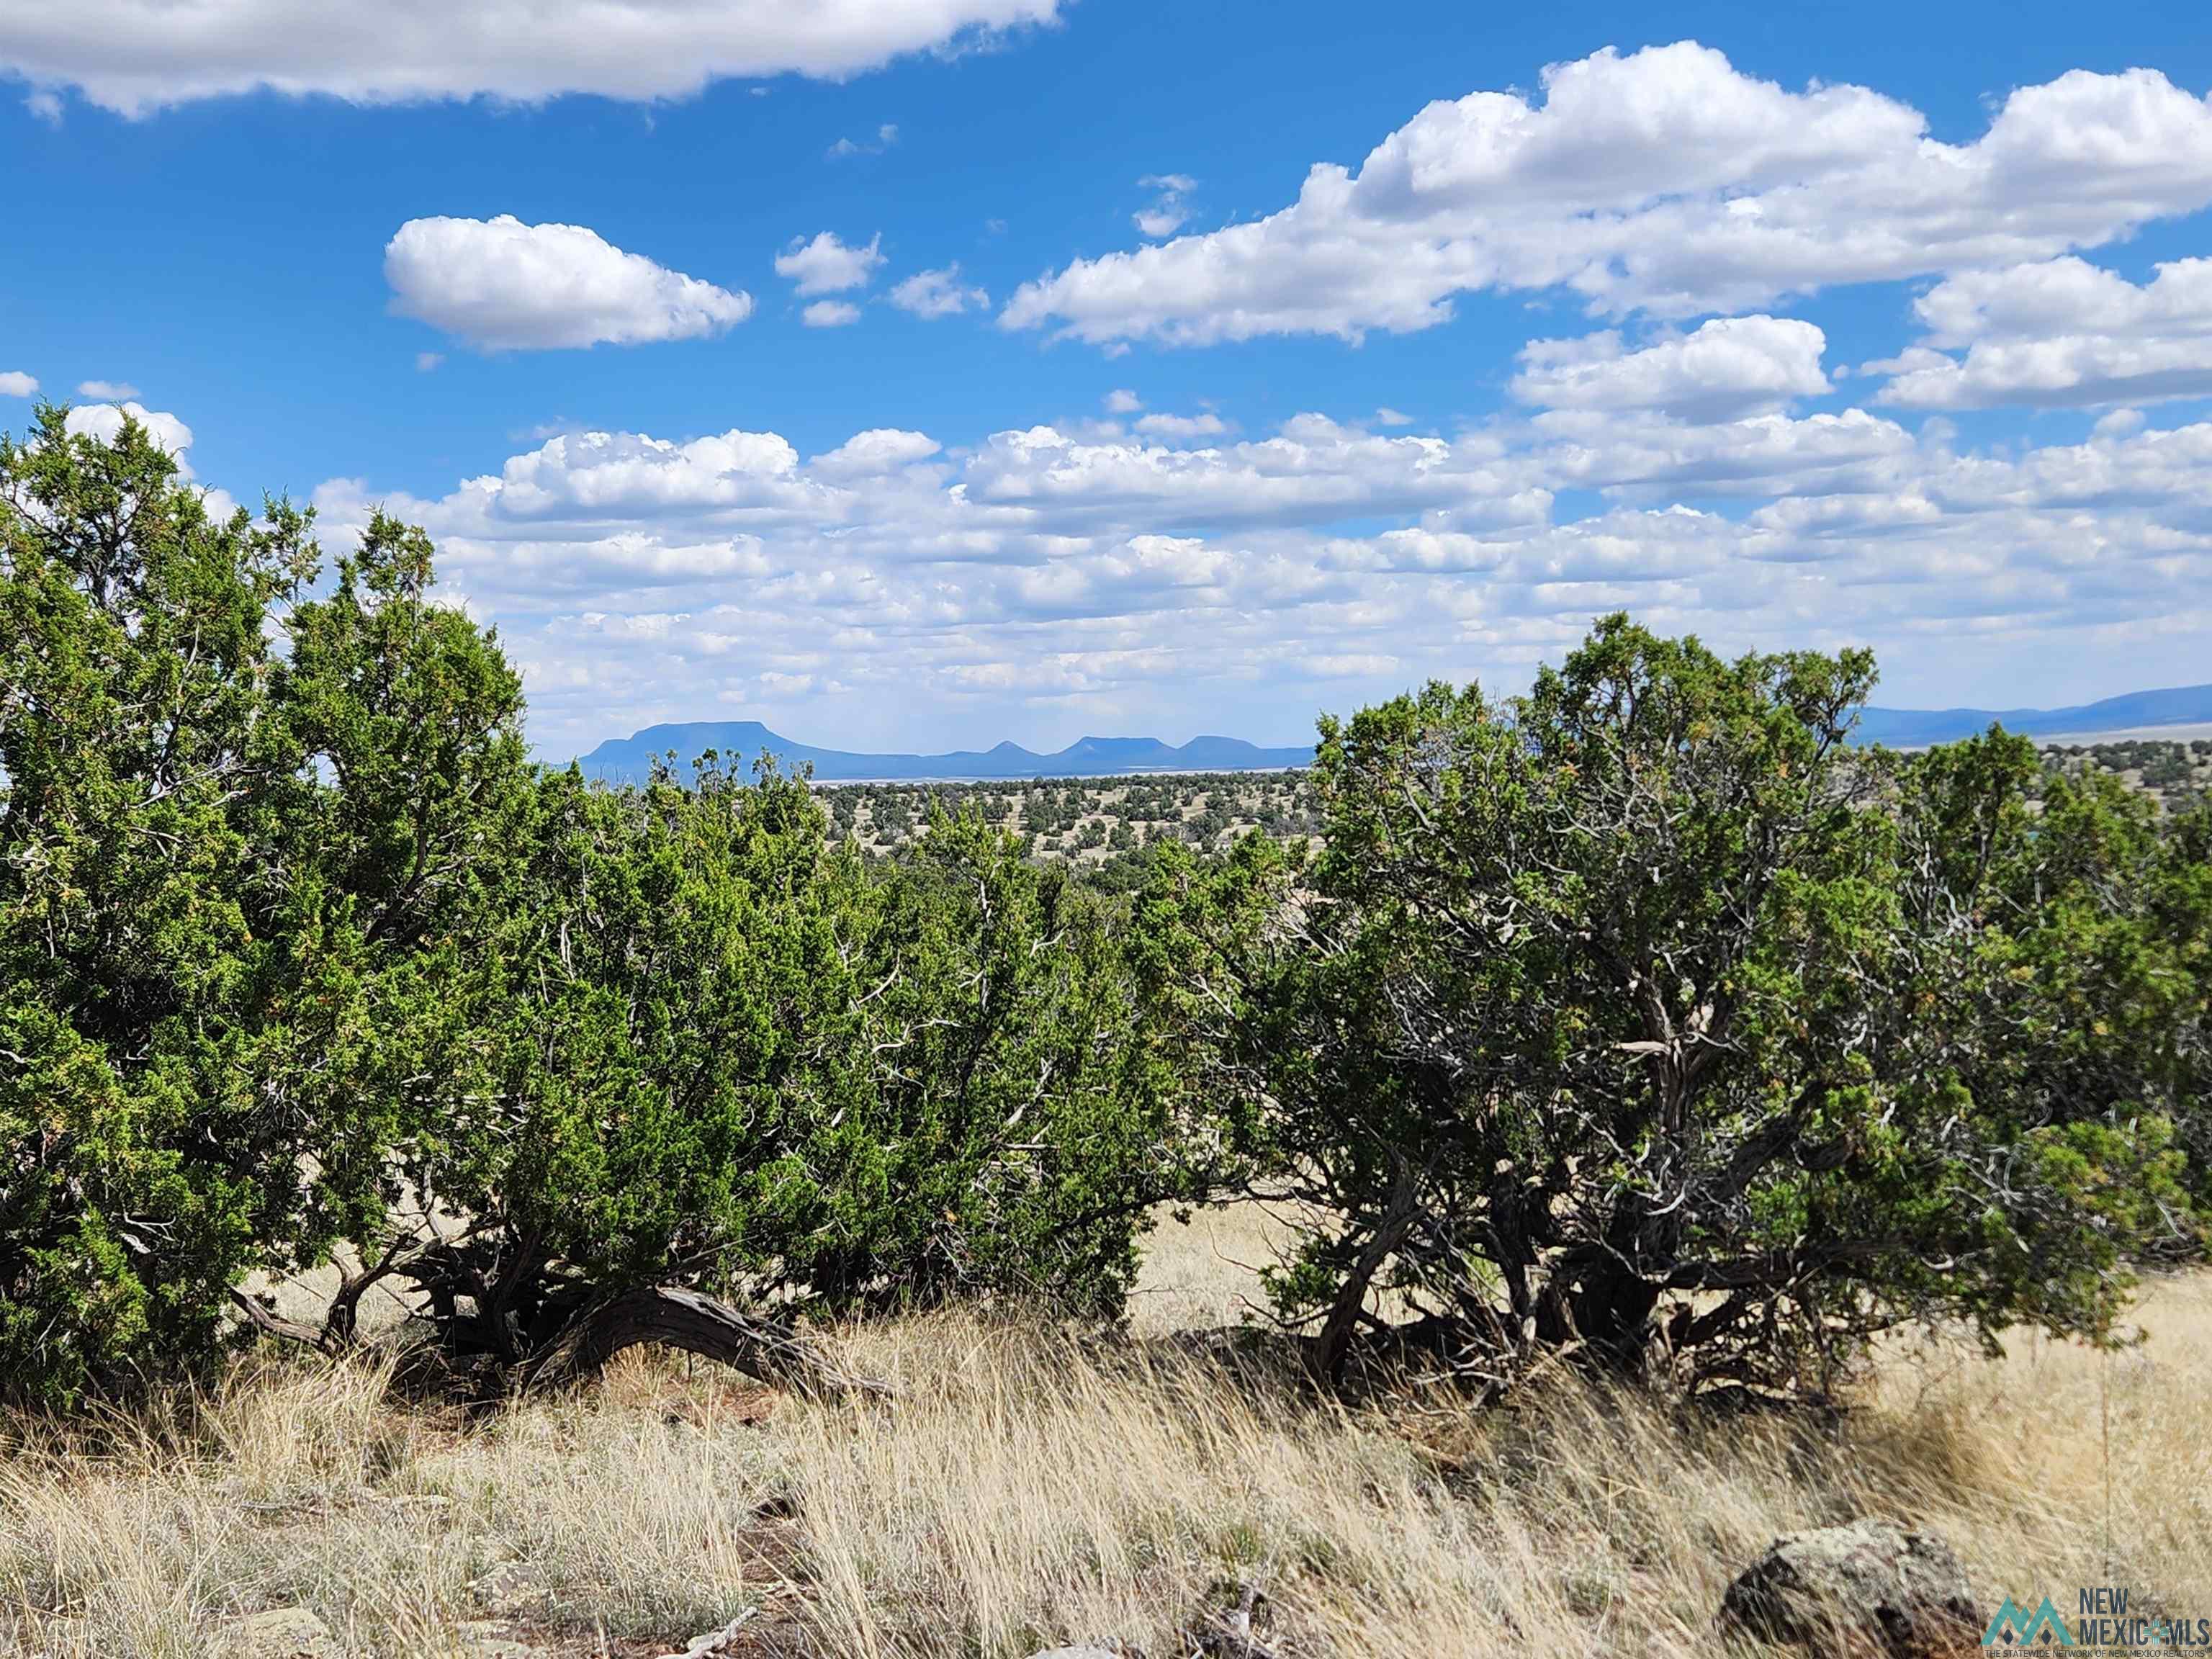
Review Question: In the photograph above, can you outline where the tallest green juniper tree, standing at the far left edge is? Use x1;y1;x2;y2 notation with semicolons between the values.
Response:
0;409;522;1401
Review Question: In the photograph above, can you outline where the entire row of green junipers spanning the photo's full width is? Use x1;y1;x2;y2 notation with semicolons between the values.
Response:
0;409;2212;1405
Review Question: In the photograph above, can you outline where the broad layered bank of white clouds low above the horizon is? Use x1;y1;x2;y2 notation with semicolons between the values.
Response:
281;407;2212;757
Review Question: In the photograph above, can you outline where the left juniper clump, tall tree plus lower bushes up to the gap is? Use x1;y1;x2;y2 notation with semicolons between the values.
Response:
0;409;1188;1403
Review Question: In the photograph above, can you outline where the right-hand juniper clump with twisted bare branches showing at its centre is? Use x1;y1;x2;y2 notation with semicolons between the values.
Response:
1146;617;2208;1387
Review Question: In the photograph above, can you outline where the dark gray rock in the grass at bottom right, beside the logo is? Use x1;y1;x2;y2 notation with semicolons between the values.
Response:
1721;1519;1982;1659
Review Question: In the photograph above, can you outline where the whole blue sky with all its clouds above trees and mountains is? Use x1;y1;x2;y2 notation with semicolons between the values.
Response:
0;0;2212;757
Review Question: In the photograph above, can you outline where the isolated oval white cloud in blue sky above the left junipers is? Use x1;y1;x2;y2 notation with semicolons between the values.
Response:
385;212;752;351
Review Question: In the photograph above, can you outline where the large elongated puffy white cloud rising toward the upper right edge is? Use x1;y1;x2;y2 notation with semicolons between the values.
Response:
1000;42;2212;345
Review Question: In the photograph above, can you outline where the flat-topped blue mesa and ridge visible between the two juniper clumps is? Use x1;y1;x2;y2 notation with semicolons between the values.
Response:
577;721;1314;783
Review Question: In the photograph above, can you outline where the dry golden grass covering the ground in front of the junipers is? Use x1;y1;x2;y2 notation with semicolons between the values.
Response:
0;1234;2212;1659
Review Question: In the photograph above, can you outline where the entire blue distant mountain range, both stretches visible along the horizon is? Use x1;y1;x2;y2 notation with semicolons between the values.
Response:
577;685;2212;783
